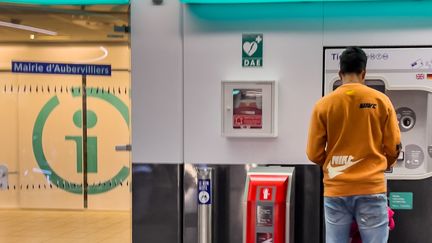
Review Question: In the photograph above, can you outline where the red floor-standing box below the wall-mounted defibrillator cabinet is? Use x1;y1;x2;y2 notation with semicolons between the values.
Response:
243;166;294;243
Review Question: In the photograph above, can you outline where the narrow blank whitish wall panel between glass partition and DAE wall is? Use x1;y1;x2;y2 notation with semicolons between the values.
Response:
131;0;183;163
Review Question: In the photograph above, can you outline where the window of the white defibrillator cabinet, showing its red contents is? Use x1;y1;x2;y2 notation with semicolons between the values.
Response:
233;89;262;129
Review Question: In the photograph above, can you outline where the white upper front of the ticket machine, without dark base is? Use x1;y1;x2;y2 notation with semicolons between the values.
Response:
324;47;432;180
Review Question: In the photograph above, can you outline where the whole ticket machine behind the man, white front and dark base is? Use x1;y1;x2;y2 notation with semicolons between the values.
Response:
323;47;432;242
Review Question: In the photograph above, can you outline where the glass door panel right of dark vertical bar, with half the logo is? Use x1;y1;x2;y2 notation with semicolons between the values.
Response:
87;70;131;210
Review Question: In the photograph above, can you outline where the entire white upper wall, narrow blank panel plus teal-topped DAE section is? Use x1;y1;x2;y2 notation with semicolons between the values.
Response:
132;0;432;163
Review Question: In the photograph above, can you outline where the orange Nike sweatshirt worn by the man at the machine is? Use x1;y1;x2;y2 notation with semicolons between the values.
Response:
307;83;401;197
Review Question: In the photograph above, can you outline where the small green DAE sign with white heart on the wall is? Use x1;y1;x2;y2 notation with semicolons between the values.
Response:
242;34;264;67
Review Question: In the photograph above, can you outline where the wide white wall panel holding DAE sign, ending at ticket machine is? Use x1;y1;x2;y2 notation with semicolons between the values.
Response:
184;3;322;163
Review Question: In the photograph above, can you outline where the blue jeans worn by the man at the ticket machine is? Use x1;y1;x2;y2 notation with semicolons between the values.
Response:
324;194;389;243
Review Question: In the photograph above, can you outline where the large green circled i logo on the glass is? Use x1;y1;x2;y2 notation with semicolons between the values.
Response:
33;88;130;194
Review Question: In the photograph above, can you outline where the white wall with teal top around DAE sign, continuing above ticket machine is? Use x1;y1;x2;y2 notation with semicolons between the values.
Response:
183;1;432;164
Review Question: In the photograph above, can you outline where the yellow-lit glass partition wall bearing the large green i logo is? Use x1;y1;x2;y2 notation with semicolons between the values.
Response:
0;5;131;242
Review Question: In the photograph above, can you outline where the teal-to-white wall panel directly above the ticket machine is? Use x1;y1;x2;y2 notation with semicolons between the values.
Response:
323;1;432;46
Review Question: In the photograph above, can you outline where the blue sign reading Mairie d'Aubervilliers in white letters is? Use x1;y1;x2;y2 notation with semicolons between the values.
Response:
12;61;111;76
